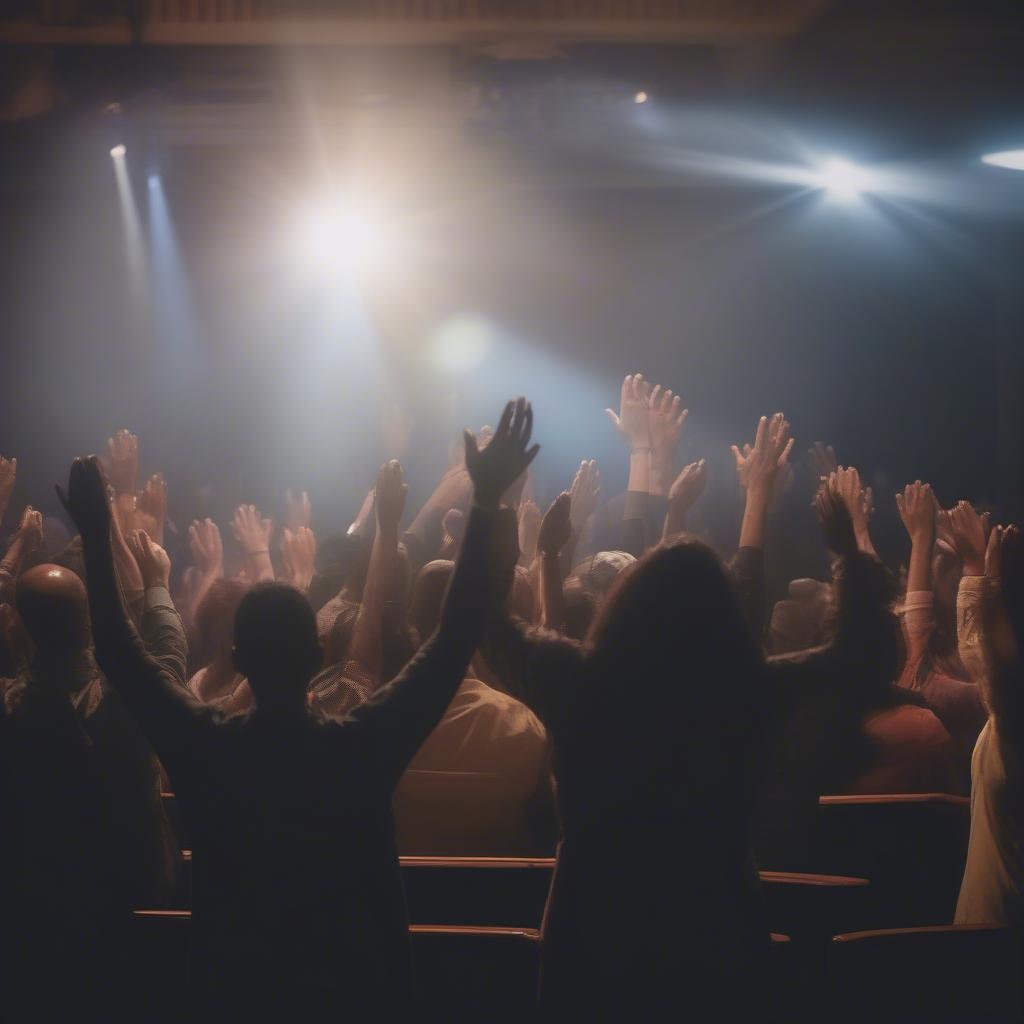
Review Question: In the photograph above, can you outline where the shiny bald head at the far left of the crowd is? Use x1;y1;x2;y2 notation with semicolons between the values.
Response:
16;564;89;655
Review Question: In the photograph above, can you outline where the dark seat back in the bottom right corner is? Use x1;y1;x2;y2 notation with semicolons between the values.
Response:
827;925;1024;1024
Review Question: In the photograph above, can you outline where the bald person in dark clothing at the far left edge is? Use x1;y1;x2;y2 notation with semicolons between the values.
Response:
0;564;174;1020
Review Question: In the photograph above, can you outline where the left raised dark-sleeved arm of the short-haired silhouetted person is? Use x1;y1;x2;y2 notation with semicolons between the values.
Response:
57;456;206;764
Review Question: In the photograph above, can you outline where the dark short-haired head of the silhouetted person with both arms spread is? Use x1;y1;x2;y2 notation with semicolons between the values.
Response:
233;583;323;708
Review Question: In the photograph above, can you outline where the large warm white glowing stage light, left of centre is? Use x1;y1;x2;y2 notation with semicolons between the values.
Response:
296;194;388;273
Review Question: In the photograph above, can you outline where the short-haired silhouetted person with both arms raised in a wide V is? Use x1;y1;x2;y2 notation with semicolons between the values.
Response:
66;399;537;1020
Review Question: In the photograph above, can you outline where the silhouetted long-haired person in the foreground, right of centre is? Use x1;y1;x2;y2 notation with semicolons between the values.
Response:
484;524;768;1020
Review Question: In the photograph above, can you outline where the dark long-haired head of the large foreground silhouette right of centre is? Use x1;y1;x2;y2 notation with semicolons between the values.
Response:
588;540;761;737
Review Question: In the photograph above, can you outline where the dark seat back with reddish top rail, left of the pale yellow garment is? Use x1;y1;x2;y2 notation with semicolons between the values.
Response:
814;794;971;928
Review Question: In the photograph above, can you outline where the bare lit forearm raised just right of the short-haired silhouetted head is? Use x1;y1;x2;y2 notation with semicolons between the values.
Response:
347;459;408;684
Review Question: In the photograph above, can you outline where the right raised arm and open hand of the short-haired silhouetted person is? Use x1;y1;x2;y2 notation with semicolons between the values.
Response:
349;398;539;783
